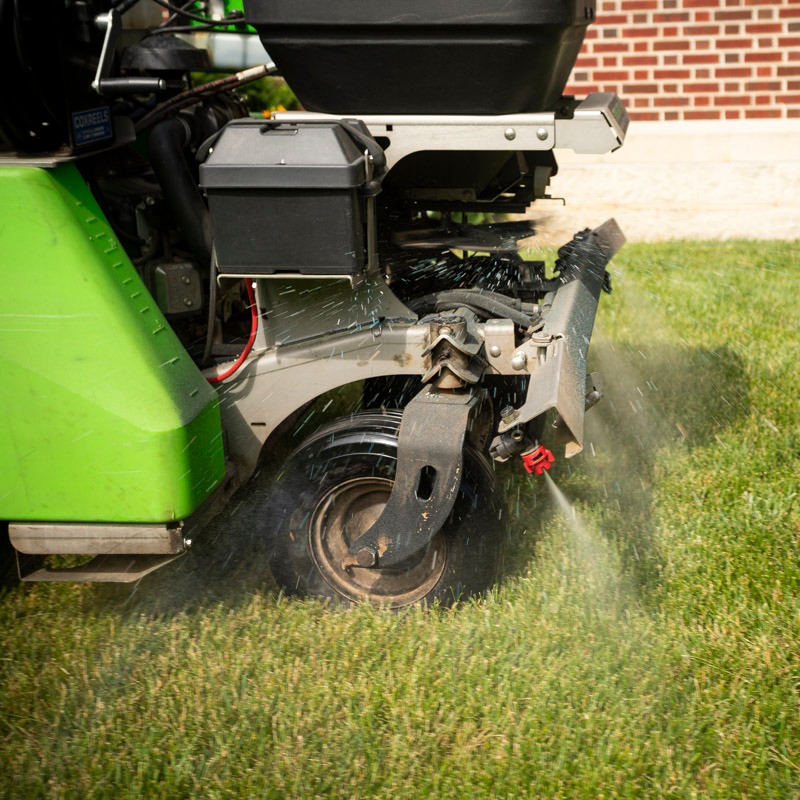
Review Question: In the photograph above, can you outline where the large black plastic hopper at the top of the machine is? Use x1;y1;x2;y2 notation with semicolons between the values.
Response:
245;0;595;115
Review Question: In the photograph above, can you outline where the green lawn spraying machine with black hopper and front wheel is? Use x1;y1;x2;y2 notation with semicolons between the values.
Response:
0;0;628;607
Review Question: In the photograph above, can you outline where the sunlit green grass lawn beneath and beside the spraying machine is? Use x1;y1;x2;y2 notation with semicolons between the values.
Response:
0;242;800;800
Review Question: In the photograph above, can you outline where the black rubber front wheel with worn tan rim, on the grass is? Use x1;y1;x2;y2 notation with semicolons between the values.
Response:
260;411;506;608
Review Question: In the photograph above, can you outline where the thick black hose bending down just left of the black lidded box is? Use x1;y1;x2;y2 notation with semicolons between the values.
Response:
147;117;212;264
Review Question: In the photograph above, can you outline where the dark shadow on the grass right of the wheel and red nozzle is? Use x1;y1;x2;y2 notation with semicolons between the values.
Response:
500;336;750;594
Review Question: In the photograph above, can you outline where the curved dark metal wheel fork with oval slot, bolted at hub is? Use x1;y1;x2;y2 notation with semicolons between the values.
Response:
343;387;485;567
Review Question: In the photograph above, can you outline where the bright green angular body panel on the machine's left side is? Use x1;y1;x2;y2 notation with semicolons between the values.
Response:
0;165;225;522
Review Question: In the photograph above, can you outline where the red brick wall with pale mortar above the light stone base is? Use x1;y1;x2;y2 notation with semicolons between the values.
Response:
566;0;800;122
